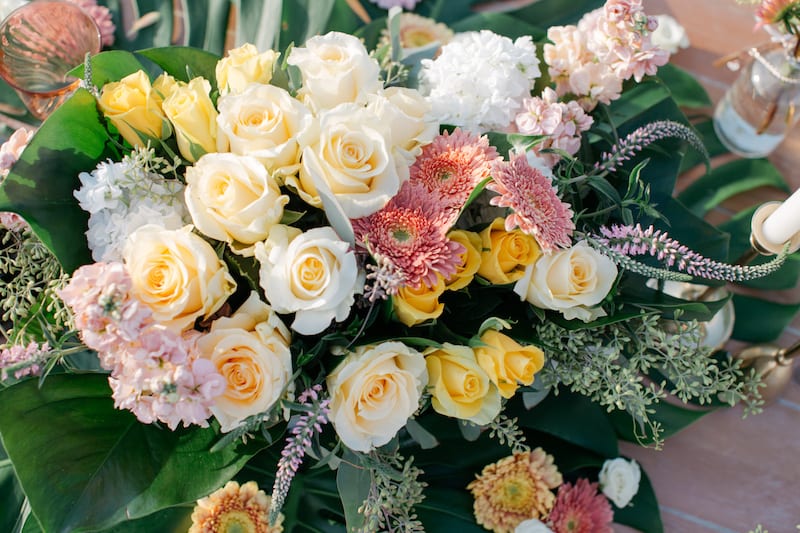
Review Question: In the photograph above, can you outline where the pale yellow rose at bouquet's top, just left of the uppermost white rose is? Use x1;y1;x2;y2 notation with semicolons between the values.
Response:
216;43;280;95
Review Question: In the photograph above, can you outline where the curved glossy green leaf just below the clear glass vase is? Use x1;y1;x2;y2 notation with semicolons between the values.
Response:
678;159;789;217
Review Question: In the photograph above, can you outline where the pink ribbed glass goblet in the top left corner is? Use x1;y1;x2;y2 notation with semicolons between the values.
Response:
0;0;101;120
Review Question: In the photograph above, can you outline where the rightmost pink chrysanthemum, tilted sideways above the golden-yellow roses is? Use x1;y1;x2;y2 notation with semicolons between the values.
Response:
486;155;575;252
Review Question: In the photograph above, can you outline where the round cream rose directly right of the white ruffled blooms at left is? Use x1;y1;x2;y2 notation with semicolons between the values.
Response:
185;153;289;256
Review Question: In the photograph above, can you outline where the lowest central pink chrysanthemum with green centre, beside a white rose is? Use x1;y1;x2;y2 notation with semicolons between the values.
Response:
353;203;464;287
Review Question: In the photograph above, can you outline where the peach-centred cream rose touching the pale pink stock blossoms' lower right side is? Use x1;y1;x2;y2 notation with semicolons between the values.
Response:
197;292;292;432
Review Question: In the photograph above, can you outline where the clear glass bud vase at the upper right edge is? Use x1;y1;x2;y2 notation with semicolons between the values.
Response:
714;44;800;158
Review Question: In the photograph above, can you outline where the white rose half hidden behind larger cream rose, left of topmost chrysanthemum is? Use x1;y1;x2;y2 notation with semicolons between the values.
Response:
368;87;439;166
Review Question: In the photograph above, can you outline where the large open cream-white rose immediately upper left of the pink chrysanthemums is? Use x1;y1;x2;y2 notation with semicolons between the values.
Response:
294;104;408;219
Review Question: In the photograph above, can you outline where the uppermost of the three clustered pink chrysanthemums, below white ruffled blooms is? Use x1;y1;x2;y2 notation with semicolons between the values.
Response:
410;129;502;213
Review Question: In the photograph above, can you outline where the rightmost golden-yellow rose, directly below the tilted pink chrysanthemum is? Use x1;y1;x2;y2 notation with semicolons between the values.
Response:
478;218;541;285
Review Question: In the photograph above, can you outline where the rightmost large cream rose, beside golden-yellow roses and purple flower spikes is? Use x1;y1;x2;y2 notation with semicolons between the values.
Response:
514;241;617;322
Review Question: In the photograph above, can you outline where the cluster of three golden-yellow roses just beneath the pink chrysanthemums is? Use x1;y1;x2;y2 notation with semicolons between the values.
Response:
392;218;541;327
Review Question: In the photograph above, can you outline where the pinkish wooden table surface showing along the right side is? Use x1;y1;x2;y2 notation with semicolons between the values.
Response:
619;0;800;533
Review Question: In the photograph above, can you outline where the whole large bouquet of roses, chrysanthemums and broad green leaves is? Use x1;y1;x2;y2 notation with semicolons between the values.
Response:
0;0;797;532
